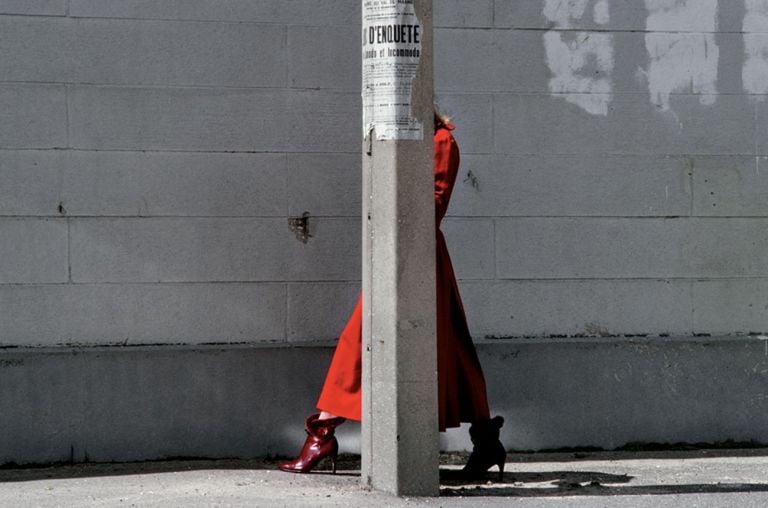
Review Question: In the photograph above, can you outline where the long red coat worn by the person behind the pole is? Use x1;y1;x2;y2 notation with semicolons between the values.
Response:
317;124;490;431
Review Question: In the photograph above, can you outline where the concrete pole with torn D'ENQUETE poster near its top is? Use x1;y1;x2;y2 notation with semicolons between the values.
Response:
362;0;439;496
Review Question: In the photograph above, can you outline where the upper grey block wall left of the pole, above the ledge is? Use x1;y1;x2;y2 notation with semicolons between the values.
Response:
0;0;361;346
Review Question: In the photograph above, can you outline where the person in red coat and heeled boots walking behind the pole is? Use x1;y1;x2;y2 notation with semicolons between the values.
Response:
279;110;506;478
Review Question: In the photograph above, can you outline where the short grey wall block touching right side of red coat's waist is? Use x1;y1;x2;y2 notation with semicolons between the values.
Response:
440;217;495;279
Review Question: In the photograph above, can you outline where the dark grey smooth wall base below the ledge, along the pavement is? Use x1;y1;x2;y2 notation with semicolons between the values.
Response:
6;338;768;464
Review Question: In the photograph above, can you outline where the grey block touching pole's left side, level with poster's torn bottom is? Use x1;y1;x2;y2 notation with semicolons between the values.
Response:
287;90;363;154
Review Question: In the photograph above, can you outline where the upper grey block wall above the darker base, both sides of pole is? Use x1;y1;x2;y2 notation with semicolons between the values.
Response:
0;0;768;460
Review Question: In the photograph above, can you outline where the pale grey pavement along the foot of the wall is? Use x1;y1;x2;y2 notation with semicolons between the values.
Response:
0;449;768;508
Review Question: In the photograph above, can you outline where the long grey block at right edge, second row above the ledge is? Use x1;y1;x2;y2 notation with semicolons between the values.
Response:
496;218;768;279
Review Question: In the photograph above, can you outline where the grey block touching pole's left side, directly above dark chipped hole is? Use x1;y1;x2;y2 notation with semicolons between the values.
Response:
287;153;362;217
